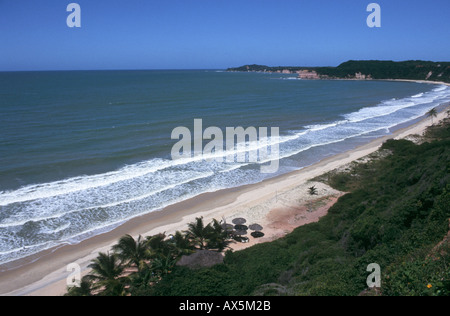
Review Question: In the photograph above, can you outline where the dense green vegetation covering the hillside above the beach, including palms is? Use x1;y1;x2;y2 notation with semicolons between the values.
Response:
69;119;450;296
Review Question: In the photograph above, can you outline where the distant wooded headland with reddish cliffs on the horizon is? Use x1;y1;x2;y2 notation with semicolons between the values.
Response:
227;60;450;83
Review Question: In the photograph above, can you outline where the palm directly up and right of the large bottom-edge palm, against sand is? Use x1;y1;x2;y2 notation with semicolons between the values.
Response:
113;235;148;271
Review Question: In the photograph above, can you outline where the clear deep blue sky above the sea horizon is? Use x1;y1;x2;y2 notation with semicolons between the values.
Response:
0;0;450;71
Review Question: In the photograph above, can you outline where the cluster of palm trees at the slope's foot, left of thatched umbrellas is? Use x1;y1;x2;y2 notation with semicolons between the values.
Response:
66;217;232;296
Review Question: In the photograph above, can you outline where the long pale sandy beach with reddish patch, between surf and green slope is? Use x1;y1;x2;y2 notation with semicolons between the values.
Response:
0;82;448;296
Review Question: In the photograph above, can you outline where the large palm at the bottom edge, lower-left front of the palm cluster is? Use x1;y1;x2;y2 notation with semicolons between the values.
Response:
85;252;125;296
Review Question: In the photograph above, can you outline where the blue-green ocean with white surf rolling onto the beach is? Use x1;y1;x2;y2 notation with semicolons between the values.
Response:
0;70;450;264
